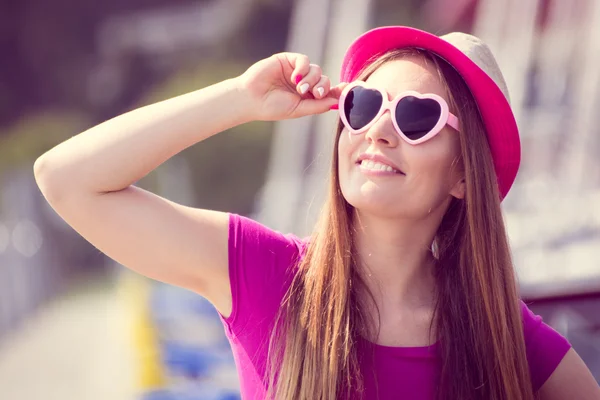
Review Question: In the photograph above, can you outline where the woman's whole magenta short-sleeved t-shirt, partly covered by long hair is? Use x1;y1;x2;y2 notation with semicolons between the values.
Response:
222;214;571;400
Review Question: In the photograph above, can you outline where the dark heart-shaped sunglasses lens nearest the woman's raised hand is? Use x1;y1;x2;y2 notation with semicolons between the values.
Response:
344;86;383;129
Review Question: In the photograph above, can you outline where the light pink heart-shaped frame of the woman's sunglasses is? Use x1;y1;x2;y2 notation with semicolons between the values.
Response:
338;81;460;145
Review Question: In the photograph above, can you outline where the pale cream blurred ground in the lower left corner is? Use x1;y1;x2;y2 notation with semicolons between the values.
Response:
0;276;135;400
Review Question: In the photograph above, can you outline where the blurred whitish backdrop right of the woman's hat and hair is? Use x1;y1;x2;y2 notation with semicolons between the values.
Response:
475;0;600;295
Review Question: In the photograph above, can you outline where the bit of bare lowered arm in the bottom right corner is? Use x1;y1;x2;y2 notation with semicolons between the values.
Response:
538;349;600;400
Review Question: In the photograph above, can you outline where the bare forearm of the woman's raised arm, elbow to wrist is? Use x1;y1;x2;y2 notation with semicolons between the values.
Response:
35;80;252;200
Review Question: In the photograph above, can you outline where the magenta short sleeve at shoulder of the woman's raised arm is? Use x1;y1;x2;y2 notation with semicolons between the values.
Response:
224;214;301;334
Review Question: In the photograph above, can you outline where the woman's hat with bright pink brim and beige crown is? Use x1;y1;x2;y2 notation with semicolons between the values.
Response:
340;26;521;199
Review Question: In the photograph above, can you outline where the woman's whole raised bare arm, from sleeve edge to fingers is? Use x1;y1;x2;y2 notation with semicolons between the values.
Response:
34;53;336;315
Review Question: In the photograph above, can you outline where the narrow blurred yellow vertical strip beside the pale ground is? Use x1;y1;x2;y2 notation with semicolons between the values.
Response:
120;271;166;391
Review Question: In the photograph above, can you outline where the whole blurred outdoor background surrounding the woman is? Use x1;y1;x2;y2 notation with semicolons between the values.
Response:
0;0;600;400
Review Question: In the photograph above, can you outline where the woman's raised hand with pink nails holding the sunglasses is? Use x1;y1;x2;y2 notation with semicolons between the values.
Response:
238;53;343;121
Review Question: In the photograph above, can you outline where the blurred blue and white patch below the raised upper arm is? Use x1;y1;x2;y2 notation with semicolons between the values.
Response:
143;282;241;400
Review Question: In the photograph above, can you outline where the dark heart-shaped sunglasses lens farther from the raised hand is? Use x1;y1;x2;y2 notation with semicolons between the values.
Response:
396;96;442;140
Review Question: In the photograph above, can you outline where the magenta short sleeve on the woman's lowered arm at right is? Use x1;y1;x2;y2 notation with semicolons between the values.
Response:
521;302;571;392
